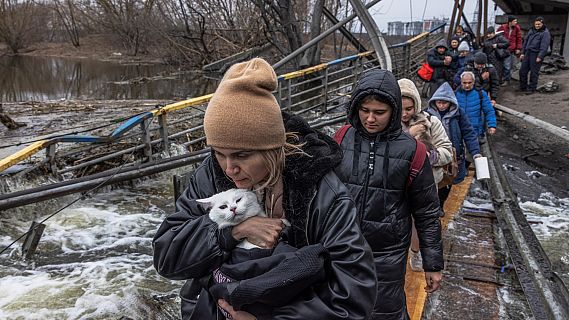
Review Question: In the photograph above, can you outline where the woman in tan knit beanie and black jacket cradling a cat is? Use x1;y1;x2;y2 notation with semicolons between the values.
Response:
153;58;376;319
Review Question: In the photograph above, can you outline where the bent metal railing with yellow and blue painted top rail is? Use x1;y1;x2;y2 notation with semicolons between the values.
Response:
0;25;444;196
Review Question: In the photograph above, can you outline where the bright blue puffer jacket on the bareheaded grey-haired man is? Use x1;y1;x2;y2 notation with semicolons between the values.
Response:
455;87;496;136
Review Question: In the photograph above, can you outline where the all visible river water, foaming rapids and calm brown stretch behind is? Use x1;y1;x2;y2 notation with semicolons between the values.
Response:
0;58;569;319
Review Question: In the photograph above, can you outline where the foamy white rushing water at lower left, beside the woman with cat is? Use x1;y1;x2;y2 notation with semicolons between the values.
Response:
0;173;185;319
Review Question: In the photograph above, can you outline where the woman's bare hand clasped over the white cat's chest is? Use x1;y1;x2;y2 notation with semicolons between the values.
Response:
231;217;285;249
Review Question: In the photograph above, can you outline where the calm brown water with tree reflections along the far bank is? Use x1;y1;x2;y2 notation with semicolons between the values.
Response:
0;56;214;102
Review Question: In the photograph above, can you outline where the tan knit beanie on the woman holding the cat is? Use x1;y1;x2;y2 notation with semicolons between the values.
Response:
204;58;285;150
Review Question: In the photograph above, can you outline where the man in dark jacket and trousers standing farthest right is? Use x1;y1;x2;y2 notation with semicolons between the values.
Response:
520;17;551;94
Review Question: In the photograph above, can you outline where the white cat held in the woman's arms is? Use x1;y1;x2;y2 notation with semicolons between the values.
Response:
196;189;268;249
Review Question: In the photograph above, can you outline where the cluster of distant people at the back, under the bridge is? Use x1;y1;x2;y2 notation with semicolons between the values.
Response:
426;15;551;99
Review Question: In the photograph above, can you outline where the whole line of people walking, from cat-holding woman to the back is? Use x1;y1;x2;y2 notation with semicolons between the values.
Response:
149;15;547;320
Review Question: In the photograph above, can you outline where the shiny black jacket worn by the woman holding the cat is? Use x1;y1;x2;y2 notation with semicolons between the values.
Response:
153;113;376;319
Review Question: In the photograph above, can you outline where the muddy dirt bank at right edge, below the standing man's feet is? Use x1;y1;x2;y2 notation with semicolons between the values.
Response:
493;70;569;200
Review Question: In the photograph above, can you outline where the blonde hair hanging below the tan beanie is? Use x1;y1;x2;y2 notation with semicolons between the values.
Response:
259;132;310;190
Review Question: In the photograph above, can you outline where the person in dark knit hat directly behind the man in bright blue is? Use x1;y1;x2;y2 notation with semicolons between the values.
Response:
454;52;500;106
